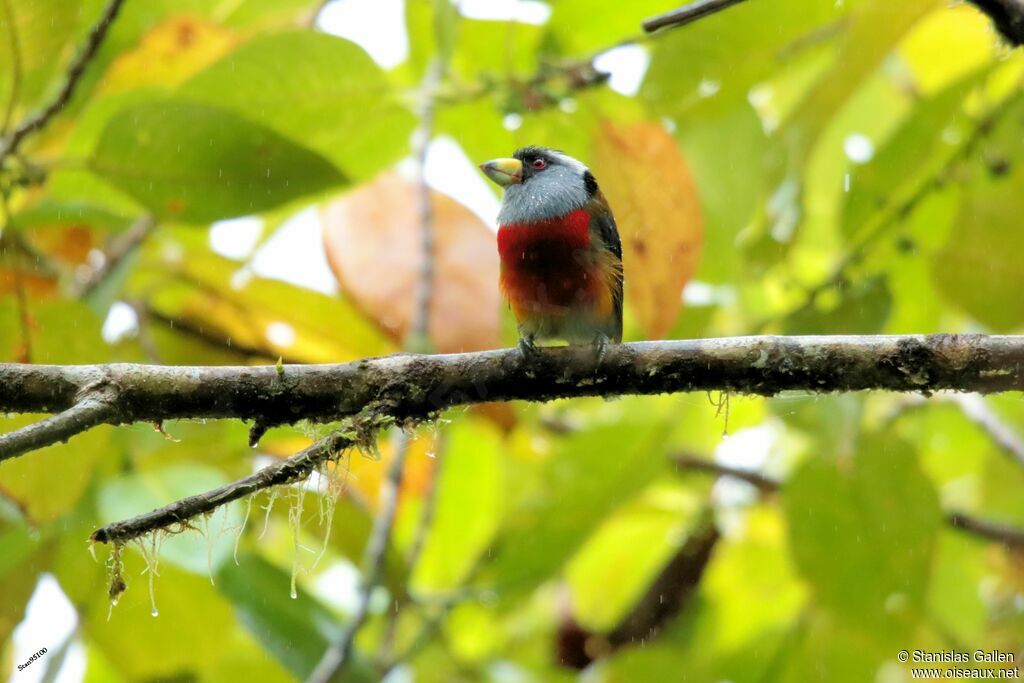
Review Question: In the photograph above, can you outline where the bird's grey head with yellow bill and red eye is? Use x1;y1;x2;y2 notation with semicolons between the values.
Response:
480;146;597;225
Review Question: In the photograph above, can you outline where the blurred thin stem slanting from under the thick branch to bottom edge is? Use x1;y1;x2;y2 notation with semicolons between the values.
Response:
306;431;411;683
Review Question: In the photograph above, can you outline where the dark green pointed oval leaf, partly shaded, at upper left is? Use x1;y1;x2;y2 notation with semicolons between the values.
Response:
88;100;345;222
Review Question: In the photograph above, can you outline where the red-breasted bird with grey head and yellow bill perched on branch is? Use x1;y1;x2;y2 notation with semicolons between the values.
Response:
480;145;624;361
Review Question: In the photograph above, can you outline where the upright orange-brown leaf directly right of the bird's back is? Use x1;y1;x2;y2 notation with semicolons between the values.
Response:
593;121;703;339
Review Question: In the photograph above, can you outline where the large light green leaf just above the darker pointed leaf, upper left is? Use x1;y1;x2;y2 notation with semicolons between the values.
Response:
180;31;415;179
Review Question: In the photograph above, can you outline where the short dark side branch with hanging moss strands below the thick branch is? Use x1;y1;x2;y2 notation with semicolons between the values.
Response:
90;430;353;543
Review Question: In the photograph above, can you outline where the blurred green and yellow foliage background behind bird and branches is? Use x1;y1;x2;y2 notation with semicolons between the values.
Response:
0;0;1024;683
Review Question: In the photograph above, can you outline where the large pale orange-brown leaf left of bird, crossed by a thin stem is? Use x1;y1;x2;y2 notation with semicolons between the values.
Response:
322;174;501;352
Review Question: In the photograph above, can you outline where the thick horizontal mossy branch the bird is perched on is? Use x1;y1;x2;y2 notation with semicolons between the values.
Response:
6;335;1024;457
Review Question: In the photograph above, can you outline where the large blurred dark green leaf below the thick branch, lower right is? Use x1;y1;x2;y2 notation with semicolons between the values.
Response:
782;436;942;633
